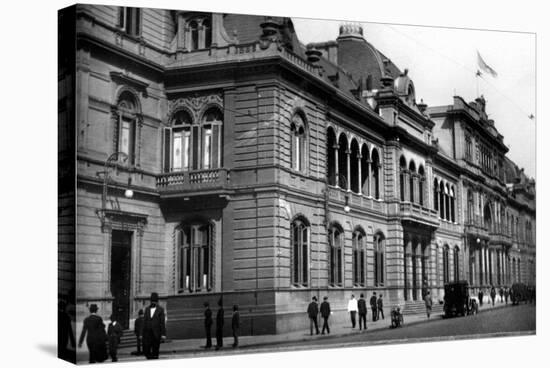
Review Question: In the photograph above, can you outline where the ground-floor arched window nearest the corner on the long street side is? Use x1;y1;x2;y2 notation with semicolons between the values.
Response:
290;219;309;286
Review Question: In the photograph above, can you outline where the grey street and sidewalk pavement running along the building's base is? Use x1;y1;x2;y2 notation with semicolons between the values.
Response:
78;303;536;361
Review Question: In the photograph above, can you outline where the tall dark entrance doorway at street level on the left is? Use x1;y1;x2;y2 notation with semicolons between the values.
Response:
111;230;132;329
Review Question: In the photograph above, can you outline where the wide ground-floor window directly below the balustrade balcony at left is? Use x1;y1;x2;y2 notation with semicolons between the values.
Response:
175;223;214;293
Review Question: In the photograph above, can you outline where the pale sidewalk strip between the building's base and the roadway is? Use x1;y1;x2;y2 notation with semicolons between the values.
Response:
77;298;512;361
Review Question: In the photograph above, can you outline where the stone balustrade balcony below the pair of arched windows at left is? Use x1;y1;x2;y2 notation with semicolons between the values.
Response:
157;169;230;197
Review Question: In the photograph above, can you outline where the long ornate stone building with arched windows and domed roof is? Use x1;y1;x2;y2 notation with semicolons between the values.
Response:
59;5;536;338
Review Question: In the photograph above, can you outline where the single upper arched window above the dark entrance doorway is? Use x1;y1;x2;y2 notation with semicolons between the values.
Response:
116;91;138;165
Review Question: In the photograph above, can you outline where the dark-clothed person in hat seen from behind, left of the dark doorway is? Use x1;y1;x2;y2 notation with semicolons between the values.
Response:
78;304;107;363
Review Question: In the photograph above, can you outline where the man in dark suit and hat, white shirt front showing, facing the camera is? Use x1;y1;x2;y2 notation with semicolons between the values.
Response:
143;293;166;359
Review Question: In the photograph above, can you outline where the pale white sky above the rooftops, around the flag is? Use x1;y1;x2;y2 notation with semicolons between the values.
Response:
293;18;536;177
